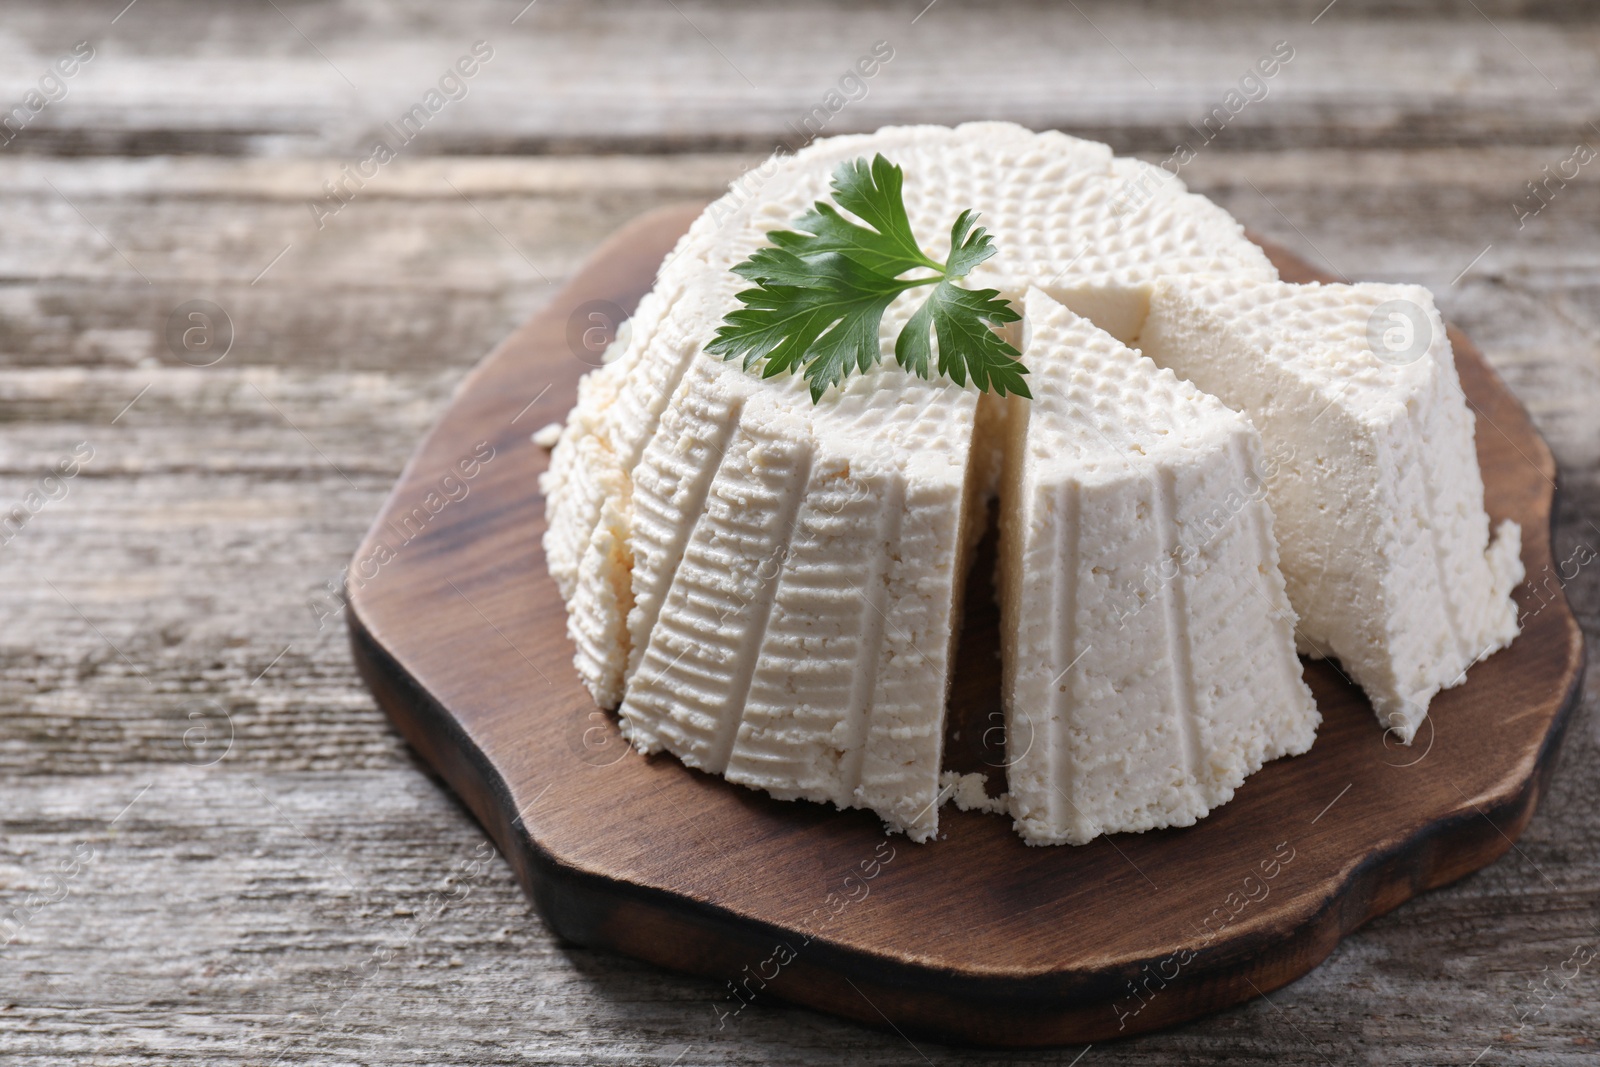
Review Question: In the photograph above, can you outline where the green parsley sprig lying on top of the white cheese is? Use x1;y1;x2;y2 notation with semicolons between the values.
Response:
706;154;1032;403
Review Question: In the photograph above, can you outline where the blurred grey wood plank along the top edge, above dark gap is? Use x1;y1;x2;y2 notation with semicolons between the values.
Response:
0;0;1600;157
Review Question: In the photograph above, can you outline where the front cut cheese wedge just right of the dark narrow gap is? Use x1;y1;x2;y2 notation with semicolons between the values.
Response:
1000;290;1320;845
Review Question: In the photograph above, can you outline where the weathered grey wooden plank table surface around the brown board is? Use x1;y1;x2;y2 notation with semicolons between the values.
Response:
0;0;1600;1067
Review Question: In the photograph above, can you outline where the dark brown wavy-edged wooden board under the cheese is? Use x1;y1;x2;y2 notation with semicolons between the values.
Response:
347;205;1584;1046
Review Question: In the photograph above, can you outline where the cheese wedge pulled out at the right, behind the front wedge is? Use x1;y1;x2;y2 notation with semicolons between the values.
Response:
1139;277;1523;744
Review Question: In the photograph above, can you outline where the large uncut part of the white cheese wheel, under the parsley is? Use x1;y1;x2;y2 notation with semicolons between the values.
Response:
542;123;1277;840
